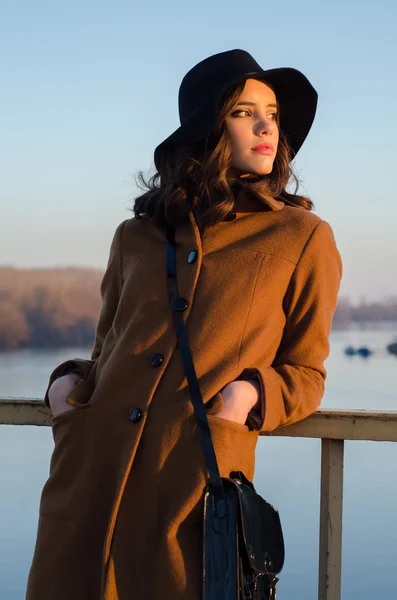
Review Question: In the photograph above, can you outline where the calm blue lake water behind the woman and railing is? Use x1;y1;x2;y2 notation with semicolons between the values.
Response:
0;324;397;600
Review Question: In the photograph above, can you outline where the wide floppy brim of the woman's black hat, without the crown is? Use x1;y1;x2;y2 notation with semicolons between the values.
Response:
154;67;318;169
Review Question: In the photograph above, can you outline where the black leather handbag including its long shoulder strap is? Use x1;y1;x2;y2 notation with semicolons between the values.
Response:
166;226;284;600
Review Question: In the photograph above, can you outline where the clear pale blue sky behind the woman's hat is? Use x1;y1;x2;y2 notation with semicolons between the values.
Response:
0;0;397;301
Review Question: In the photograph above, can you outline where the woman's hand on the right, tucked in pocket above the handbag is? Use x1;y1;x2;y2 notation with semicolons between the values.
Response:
214;379;260;425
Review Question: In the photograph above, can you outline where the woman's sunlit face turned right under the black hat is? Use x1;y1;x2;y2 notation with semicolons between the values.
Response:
225;79;279;175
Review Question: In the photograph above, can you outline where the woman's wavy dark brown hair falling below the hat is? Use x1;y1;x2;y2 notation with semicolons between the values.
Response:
131;81;314;229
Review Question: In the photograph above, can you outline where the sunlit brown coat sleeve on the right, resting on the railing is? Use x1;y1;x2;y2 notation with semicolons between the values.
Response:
240;220;342;432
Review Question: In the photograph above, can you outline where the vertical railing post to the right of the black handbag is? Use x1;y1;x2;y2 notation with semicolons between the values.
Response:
318;439;344;600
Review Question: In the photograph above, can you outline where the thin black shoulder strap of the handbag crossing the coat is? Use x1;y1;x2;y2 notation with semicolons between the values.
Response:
166;225;225;506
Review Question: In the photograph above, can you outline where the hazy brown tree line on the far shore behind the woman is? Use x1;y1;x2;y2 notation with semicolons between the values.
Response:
0;267;397;350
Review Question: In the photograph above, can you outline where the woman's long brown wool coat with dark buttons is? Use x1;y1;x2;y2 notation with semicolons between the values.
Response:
27;183;342;600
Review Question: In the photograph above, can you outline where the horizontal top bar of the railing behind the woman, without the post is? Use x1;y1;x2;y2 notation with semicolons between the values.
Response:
0;397;397;442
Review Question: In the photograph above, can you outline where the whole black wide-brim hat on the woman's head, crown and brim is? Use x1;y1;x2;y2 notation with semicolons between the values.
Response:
154;49;318;169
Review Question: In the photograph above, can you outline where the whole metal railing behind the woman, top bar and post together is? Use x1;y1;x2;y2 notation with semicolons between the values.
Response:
0;398;397;600
